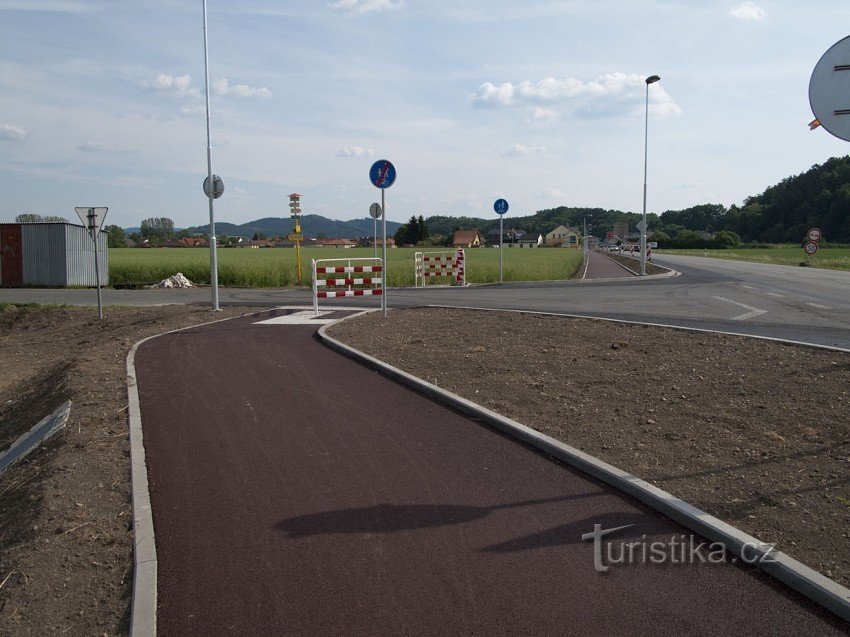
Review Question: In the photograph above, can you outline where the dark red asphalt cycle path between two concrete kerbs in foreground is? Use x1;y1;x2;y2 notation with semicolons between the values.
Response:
136;310;844;635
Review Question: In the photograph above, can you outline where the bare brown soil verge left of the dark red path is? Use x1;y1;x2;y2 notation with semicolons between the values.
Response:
0;304;250;635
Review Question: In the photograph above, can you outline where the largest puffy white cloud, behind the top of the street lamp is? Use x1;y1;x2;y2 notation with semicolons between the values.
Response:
470;72;681;121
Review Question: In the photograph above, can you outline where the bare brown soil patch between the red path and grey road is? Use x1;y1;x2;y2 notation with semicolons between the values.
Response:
329;309;850;586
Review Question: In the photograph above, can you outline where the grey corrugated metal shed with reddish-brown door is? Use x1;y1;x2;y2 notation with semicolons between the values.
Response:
0;223;109;287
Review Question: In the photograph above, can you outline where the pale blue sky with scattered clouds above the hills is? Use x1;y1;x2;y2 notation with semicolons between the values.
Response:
0;0;850;227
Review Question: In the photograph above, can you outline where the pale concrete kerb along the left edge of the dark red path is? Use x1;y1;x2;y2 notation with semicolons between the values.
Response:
127;312;272;637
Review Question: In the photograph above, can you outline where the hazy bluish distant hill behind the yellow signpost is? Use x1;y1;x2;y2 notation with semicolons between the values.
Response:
184;215;401;239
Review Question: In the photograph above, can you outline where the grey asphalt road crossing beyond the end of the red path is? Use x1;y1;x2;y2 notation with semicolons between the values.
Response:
0;255;850;348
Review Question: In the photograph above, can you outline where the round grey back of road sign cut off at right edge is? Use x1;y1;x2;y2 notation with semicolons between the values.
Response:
809;36;850;141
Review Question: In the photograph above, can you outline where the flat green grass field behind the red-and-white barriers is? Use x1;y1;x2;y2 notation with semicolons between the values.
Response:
109;248;582;287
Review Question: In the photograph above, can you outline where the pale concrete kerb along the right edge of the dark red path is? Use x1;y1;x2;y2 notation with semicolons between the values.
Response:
319;308;850;622
